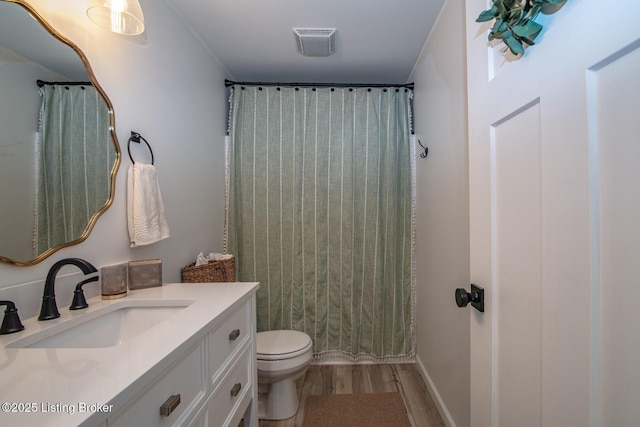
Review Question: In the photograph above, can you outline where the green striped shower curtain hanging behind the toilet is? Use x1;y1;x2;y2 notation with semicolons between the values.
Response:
226;85;414;360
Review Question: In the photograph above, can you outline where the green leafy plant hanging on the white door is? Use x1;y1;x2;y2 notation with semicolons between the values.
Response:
476;0;566;55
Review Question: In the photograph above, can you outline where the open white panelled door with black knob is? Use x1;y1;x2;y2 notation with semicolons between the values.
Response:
466;0;640;427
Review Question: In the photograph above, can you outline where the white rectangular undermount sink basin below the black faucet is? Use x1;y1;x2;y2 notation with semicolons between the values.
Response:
6;300;193;348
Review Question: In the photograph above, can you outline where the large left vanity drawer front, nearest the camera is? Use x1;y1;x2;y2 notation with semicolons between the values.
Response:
108;343;207;427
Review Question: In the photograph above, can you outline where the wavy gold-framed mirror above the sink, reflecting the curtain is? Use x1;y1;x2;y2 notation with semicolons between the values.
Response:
0;0;121;266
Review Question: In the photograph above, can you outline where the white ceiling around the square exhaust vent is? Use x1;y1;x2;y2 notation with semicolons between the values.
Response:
165;0;444;84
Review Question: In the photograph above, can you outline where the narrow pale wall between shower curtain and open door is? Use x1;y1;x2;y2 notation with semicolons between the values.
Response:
412;0;470;427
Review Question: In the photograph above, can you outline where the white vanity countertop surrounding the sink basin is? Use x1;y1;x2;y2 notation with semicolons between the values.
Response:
0;283;258;427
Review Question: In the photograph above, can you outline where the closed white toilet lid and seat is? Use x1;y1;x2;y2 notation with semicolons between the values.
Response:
256;331;311;360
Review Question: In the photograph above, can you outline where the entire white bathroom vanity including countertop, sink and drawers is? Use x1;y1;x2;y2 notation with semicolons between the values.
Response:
0;283;259;427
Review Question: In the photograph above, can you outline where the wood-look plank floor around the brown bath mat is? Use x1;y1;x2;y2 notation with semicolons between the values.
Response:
259;363;445;427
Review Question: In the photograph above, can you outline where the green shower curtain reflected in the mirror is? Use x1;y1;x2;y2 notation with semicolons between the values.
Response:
34;84;117;256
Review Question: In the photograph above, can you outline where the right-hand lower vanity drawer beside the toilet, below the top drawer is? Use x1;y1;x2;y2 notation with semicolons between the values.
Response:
209;346;254;427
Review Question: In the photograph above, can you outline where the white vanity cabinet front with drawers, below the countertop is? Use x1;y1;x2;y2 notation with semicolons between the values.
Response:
107;290;258;427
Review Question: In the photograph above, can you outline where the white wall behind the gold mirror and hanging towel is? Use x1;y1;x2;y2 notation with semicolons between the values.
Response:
0;0;232;317
